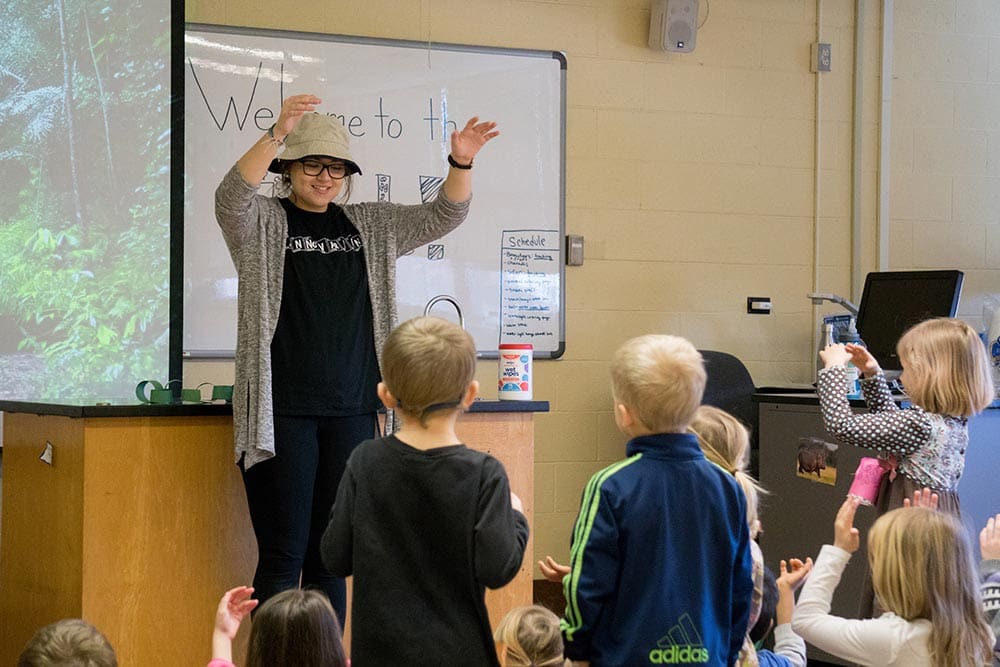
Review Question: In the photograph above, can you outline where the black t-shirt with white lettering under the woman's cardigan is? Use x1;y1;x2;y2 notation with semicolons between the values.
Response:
271;199;380;417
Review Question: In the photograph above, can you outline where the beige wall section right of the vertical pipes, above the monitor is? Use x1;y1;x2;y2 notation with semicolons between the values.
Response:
889;0;1000;316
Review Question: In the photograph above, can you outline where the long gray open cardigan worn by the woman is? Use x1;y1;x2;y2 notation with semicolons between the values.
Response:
215;166;469;468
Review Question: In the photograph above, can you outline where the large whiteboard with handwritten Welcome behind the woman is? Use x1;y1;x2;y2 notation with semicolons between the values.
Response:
183;23;566;358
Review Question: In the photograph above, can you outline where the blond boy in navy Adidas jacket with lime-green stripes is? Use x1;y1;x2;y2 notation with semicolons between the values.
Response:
539;335;753;667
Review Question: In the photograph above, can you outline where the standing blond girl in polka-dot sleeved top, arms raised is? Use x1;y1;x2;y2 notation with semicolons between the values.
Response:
817;318;994;612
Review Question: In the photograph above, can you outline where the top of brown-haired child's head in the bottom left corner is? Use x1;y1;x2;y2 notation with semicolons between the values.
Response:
17;618;118;667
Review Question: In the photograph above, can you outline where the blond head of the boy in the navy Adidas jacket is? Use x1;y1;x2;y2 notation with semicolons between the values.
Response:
611;334;706;433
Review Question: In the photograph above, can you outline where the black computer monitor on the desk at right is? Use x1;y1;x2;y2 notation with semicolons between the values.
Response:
858;271;965;377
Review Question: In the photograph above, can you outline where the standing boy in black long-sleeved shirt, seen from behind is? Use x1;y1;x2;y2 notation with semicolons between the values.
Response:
321;317;528;667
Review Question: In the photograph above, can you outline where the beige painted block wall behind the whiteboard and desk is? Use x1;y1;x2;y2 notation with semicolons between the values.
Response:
185;0;1000;572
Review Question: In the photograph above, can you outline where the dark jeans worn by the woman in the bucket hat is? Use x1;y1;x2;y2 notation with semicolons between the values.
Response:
240;414;377;627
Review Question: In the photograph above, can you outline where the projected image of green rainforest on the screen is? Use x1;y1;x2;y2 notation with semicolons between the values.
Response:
0;0;170;404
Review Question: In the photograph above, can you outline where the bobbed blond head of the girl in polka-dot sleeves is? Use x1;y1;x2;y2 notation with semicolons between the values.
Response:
896;317;995;417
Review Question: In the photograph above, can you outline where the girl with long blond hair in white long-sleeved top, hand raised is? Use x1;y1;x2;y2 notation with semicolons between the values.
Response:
792;497;993;667
